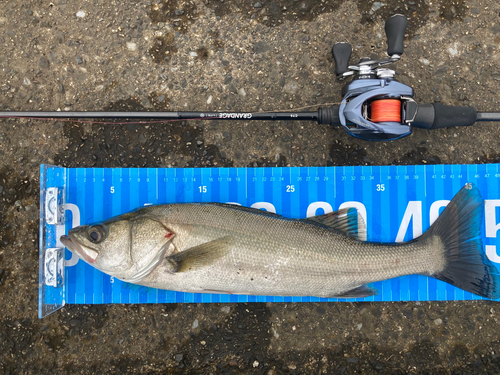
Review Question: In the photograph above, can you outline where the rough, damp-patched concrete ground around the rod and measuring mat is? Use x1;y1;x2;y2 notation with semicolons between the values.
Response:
0;0;500;375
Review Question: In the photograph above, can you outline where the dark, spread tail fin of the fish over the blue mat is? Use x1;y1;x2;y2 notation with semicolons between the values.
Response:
424;184;500;299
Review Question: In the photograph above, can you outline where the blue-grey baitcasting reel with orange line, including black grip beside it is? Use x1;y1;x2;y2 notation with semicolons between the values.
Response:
320;14;477;140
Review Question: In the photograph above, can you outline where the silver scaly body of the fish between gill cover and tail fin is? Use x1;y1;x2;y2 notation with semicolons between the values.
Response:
137;204;444;297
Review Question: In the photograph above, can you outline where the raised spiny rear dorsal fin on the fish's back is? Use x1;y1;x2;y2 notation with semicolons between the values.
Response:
303;207;366;240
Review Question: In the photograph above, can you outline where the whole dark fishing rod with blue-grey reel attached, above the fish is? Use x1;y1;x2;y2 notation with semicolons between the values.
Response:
0;14;500;141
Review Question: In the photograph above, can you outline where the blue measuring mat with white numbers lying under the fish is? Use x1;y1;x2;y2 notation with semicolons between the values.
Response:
44;164;500;304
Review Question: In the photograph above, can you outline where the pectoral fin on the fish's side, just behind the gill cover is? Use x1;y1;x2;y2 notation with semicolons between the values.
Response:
166;236;233;273
